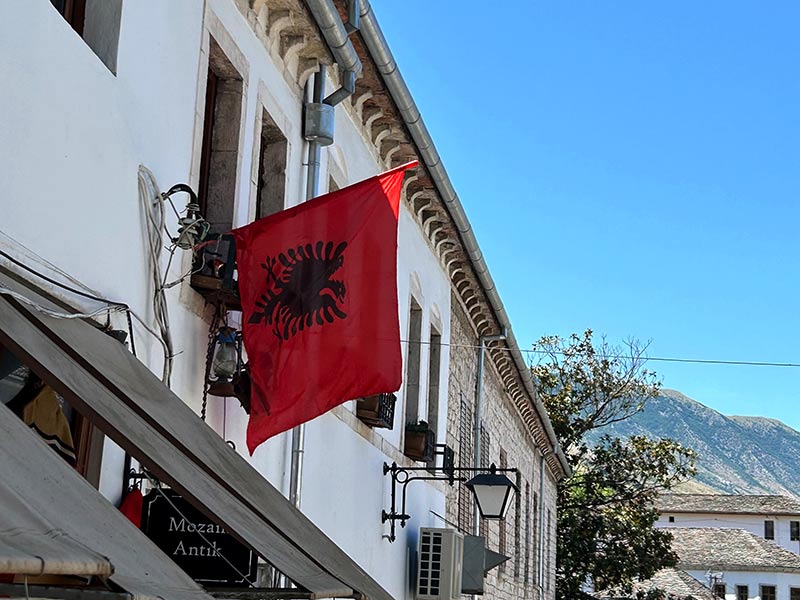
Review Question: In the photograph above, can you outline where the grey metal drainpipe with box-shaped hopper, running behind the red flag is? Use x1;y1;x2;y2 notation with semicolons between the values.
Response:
289;0;362;508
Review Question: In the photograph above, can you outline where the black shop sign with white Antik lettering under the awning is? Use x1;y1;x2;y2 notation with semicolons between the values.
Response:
142;489;258;587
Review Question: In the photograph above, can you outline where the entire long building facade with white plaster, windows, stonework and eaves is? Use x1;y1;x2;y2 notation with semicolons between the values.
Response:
0;0;568;599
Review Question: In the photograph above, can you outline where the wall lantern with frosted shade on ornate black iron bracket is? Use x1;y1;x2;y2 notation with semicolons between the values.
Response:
381;462;517;542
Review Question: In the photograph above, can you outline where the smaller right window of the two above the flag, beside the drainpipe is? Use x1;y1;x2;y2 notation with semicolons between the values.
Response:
255;110;288;219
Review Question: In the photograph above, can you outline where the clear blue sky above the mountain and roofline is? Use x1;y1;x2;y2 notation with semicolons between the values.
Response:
372;0;800;429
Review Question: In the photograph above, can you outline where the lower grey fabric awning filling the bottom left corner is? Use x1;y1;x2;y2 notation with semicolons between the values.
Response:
0;398;212;600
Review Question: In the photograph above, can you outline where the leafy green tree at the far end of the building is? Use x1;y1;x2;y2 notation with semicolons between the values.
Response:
532;330;694;600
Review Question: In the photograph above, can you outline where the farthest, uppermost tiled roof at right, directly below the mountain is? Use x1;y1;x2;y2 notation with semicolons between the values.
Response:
656;494;800;515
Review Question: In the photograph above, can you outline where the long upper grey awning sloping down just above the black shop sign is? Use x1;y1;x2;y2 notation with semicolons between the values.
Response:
0;273;391;600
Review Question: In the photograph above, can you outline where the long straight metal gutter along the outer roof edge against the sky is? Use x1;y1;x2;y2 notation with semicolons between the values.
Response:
359;0;571;474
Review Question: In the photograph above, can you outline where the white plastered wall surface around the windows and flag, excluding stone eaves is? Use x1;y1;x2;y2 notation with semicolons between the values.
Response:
0;0;450;597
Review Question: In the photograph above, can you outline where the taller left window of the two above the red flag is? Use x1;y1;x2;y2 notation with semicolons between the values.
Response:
198;39;242;233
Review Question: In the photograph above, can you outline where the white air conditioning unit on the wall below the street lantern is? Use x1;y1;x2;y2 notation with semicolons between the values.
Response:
417;527;464;600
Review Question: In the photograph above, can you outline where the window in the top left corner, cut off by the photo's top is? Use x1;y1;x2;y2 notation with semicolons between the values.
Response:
50;0;122;73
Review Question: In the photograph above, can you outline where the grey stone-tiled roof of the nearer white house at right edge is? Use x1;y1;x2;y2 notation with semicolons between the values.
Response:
668;527;800;573
